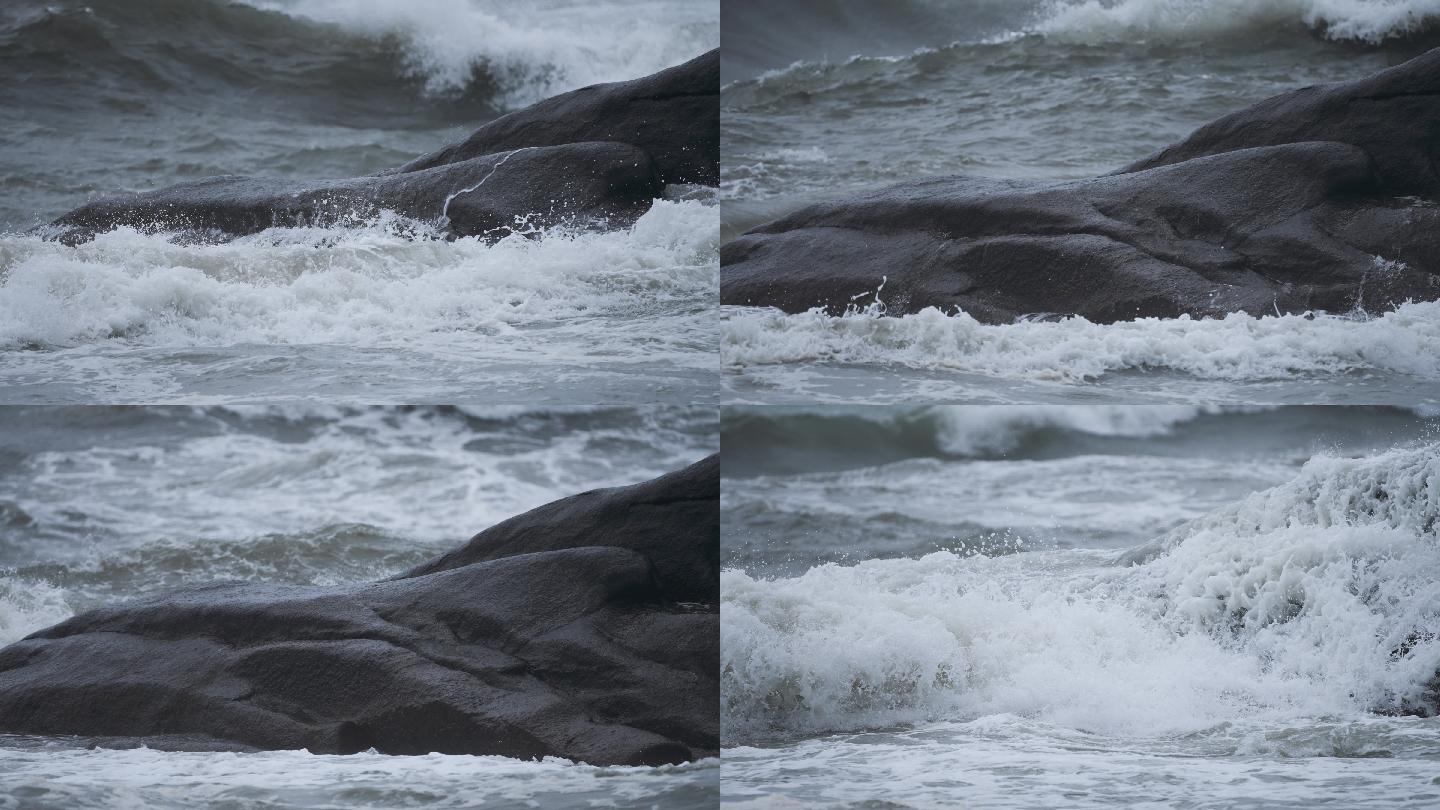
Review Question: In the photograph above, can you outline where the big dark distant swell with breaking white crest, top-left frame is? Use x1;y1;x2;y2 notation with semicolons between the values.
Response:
0;0;716;118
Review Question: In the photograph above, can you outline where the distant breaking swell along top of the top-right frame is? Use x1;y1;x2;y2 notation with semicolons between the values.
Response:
726;0;1440;92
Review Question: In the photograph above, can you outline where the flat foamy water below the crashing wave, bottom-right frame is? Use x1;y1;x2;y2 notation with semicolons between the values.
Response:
723;726;1434;810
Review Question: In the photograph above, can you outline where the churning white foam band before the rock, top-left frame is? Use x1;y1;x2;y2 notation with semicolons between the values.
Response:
0;200;719;350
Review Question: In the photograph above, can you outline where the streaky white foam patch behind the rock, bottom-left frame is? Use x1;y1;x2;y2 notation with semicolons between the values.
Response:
9;406;710;553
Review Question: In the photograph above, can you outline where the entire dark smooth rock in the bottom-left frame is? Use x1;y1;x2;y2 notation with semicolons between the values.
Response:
0;458;720;764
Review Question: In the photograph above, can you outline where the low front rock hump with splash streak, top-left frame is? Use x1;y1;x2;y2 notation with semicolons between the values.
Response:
50;143;662;245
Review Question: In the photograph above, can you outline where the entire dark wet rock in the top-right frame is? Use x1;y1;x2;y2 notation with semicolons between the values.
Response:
720;49;1440;323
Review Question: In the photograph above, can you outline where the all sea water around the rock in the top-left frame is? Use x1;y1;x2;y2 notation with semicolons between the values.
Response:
0;0;719;406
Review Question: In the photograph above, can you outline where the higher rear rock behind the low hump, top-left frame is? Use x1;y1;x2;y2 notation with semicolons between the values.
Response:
399;49;720;186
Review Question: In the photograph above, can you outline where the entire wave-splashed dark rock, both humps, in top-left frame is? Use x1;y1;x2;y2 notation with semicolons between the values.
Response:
42;50;720;245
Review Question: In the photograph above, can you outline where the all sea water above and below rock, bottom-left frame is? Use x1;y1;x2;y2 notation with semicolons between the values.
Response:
0;405;719;809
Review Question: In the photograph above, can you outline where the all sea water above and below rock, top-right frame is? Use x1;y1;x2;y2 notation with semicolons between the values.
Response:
720;0;1440;405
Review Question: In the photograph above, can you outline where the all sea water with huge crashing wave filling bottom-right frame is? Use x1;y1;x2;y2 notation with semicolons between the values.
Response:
721;404;1440;809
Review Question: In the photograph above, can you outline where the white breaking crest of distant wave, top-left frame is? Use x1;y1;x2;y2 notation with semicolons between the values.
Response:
248;0;720;107
